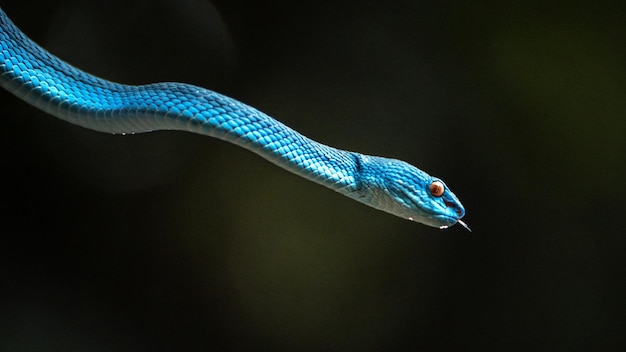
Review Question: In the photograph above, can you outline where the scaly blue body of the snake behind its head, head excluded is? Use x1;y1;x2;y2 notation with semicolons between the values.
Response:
0;9;360;195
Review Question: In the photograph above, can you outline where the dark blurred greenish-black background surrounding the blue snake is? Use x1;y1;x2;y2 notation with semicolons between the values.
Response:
0;0;626;351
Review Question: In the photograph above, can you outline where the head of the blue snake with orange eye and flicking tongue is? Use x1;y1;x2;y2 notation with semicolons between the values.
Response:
354;156;469;230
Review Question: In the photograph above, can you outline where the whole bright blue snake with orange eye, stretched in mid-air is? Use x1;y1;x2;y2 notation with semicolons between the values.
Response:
0;9;469;230
